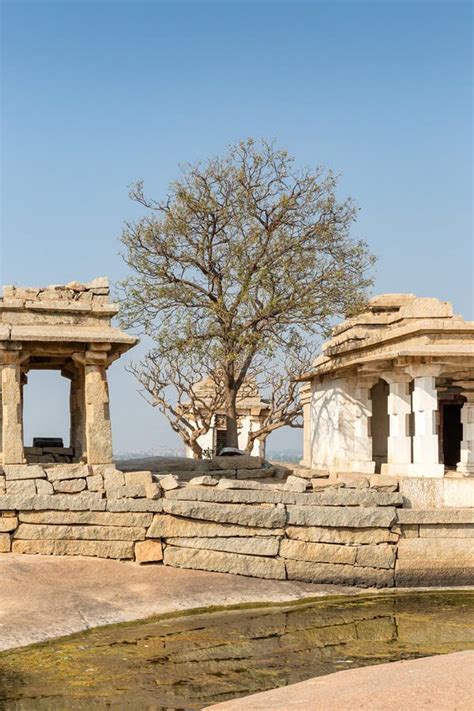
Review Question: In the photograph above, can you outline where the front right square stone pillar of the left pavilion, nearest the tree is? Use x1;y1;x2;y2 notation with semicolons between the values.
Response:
84;363;113;464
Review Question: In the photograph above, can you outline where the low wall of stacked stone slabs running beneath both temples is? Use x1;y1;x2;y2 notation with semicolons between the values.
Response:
0;457;474;587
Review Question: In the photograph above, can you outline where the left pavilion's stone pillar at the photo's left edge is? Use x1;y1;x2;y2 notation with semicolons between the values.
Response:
2;351;25;464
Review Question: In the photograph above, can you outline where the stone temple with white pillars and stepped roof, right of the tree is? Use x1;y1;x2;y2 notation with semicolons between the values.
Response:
301;294;474;477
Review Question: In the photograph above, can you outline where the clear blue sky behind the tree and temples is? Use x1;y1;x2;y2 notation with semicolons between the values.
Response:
0;0;473;450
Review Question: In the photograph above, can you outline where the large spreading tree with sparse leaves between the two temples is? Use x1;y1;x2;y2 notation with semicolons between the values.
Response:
122;139;373;447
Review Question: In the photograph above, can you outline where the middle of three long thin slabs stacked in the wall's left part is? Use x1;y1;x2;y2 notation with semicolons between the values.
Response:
14;523;145;541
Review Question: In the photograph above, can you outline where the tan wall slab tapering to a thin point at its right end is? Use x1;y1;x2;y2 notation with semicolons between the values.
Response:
147;514;284;538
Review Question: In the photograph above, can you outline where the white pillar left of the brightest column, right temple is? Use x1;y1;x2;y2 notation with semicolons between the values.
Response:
382;373;412;474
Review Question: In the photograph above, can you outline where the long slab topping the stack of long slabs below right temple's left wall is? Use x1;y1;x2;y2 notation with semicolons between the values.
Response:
286;502;396;528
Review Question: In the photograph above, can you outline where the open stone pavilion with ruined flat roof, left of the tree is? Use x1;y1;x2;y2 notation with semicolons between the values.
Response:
0;278;137;465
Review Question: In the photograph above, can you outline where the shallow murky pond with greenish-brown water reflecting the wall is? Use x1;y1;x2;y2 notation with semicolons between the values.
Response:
0;591;474;711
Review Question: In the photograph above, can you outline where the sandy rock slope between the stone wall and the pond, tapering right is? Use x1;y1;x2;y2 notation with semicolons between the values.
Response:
0;553;360;650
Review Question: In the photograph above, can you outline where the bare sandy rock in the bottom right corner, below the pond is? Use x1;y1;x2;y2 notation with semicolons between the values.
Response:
203;651;474;711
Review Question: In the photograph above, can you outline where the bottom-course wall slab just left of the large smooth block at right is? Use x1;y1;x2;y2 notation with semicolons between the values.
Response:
285;560;393;587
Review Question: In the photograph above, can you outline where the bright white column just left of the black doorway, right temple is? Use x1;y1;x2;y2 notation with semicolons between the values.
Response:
406;365;444;477
